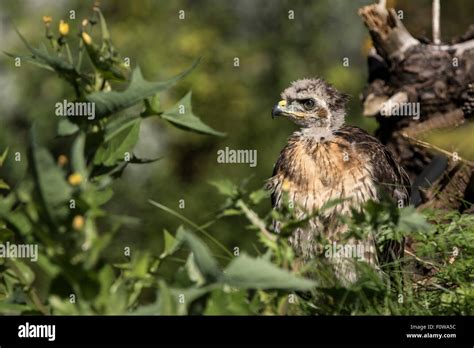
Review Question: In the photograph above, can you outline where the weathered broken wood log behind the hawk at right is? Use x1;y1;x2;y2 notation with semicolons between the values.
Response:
359;1;474;209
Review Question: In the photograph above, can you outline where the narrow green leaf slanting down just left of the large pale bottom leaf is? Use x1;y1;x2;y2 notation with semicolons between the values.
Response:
178;226;222;282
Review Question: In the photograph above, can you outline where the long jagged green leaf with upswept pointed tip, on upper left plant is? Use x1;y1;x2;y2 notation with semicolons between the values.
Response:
86;60;199;118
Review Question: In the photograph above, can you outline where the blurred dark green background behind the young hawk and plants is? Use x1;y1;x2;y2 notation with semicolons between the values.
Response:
0;0;474;257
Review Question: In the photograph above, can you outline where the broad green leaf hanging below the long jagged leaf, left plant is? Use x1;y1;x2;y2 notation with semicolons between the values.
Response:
94;118;141;166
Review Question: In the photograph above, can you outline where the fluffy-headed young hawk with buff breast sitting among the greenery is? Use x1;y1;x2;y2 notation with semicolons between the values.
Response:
268;79;410;282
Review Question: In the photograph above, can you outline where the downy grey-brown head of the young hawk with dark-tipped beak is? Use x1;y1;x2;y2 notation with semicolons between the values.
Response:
272;79;348;129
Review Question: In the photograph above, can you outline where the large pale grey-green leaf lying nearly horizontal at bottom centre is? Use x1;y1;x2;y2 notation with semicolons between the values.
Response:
221;254;316;290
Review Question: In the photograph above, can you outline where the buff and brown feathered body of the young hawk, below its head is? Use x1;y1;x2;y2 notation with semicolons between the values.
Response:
269;126;409;263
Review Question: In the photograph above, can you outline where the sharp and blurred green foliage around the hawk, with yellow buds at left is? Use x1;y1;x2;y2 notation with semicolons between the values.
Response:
0;7;474;315
